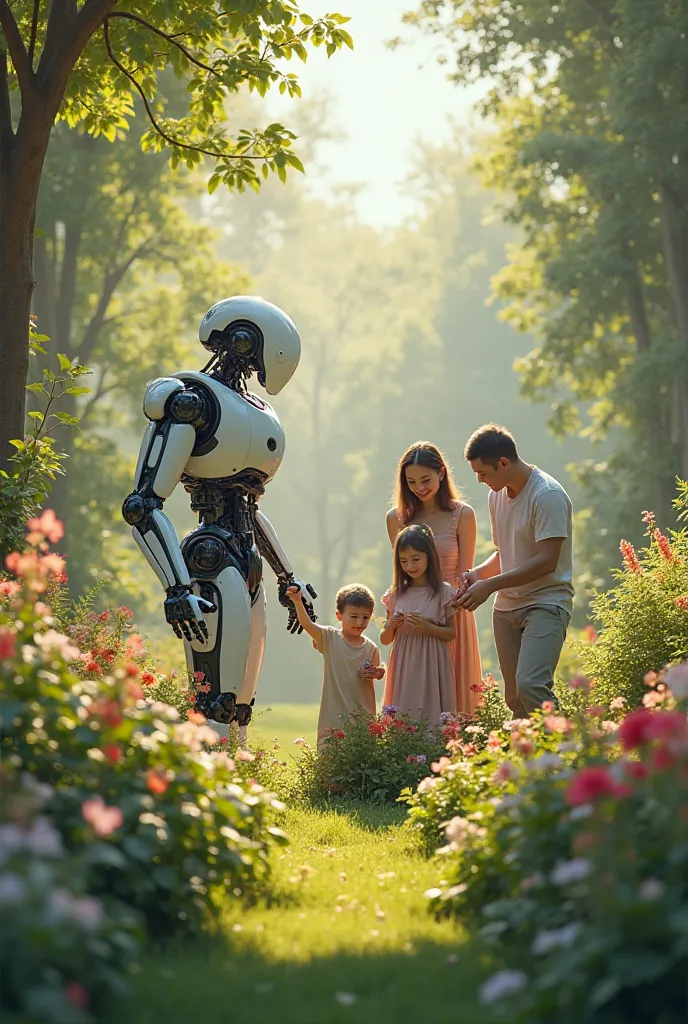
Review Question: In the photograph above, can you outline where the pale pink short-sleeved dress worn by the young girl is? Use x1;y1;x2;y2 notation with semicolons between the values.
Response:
382;583;457;723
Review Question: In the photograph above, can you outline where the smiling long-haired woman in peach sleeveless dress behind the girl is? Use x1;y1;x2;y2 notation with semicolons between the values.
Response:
387;441;482;714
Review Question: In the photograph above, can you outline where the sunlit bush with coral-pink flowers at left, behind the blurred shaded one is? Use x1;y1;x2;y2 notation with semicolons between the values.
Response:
0;512;283;936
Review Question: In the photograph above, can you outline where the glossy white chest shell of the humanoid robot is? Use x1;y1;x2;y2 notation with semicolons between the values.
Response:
186;382;285;479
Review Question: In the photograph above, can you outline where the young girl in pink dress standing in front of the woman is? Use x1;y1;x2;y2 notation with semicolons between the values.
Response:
380;526;457;723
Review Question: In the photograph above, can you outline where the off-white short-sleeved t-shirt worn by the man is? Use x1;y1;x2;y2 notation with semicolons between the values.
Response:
489;466;573;615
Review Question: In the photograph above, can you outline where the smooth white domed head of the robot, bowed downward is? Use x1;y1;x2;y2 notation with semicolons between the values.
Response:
199;295;301;394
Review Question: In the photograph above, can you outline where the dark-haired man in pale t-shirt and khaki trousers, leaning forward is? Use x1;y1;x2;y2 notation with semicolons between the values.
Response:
457;423;573;718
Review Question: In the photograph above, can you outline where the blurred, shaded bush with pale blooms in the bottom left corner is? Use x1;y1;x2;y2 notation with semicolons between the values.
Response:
0;764;141;1024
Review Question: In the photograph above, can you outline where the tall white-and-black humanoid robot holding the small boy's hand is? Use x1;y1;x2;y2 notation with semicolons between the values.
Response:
122;296;316;738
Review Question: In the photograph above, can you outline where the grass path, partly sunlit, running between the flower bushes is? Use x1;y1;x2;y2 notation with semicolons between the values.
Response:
127;807;484;1024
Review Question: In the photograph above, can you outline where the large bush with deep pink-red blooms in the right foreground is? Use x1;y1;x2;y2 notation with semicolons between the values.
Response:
413;666;688;1024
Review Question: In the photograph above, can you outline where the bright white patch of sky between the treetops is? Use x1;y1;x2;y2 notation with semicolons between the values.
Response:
271;0;477;227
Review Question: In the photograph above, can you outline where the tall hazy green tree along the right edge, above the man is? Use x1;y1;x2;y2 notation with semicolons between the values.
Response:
407;0;688;577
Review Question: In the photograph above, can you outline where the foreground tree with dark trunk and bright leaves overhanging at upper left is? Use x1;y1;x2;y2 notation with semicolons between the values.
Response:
0;0;352;460
